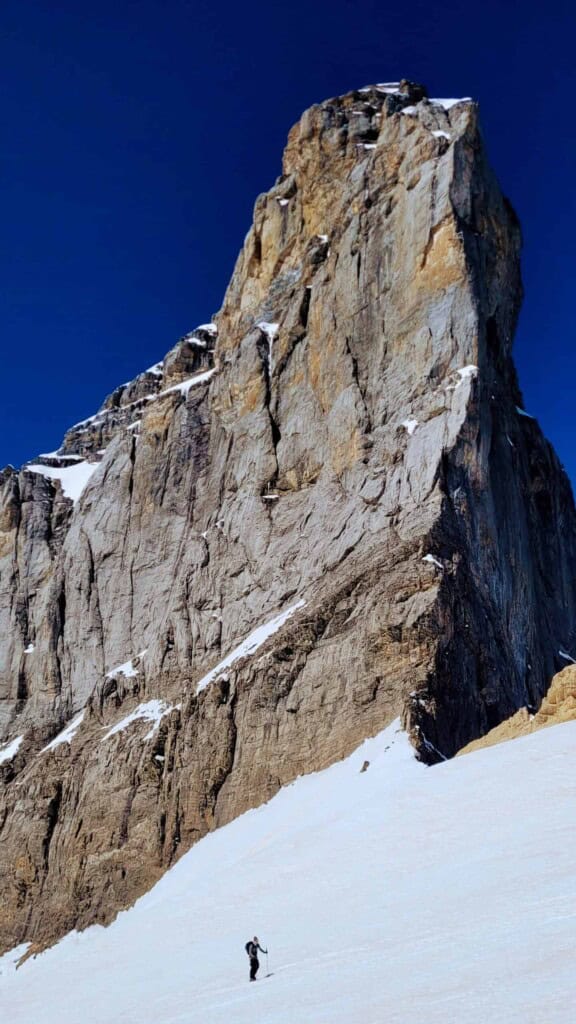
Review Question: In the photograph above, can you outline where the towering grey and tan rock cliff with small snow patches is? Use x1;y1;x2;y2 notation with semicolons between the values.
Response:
0;83;576;947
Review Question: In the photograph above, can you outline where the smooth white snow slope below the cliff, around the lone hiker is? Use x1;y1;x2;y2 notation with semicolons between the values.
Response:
0;723;576;1024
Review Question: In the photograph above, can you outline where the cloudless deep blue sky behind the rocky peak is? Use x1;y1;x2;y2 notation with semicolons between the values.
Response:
0;0;576;480
